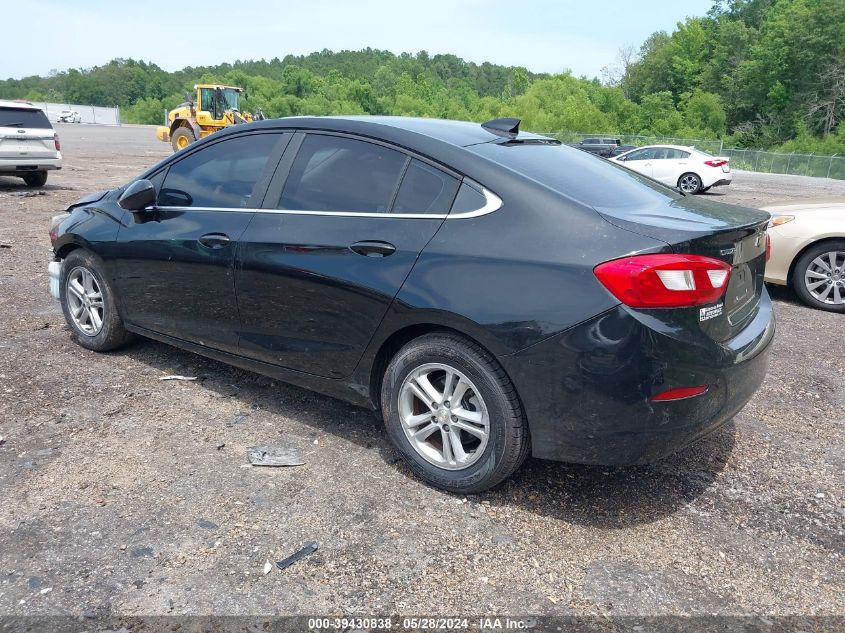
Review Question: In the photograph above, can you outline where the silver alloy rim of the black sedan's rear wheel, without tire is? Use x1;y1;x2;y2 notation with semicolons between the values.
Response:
399;363;490;470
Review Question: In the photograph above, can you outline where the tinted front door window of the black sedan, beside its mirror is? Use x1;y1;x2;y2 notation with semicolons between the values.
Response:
158;133;283;209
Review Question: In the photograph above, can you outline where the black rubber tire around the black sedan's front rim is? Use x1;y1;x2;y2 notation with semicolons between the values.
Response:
59;248;132;352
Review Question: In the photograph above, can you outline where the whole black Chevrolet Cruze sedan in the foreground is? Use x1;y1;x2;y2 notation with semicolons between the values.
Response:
44;117;774;493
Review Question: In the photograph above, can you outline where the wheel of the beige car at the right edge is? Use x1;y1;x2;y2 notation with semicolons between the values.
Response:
792;240;845;312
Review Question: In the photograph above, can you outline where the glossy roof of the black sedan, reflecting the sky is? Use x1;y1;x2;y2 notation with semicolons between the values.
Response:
247;115;546;147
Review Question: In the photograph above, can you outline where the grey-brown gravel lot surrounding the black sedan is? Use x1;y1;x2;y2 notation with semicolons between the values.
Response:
0;125;845;615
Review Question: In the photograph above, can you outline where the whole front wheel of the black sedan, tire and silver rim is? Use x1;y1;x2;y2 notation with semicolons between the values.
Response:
59;249;132;352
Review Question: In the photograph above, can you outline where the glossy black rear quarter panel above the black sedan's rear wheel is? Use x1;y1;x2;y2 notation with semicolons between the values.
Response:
360;179;666;356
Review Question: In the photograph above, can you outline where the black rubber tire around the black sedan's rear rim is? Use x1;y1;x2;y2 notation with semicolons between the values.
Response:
381;332;531;494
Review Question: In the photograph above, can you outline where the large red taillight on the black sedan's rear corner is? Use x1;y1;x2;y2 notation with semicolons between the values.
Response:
593;254;731;308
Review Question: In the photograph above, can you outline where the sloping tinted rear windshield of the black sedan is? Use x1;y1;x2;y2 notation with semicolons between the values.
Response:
467;143;682;209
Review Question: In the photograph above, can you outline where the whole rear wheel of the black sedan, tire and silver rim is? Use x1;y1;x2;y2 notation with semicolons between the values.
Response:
381;333;530;494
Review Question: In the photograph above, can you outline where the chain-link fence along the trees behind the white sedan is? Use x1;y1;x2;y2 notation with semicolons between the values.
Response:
541;132;845;180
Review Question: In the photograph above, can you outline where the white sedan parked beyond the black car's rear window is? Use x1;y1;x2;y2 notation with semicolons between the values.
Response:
609;145;733;193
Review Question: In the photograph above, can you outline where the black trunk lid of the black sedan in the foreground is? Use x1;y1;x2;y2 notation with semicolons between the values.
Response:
597;196;769;341
